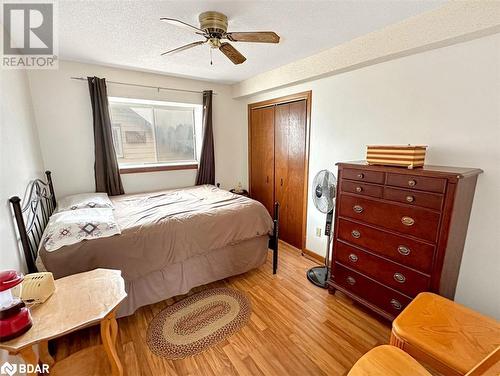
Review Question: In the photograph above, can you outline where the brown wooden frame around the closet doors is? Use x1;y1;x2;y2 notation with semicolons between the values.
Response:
248;90;312;252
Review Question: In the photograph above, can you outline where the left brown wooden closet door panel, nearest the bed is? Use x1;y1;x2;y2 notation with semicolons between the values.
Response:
249;106;274;216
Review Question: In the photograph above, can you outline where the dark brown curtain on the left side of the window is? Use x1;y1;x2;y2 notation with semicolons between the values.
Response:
87;77;124;196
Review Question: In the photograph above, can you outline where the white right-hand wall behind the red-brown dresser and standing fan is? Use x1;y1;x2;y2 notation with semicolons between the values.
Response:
240;34;500;318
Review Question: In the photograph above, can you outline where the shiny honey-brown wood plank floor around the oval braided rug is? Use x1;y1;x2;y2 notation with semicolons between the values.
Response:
51;244;390;376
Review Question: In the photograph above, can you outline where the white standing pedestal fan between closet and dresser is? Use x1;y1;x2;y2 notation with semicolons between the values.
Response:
307;170;337;288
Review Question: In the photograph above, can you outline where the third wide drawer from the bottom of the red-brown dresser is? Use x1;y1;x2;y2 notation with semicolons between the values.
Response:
334;219;434;274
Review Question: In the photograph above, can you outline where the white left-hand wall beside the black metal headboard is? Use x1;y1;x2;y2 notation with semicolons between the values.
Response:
0;70;43;271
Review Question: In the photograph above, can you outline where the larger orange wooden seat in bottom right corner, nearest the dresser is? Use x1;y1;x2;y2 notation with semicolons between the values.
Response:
390;292;500;376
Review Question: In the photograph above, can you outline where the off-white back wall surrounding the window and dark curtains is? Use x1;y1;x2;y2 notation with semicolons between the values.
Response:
29;61;247;196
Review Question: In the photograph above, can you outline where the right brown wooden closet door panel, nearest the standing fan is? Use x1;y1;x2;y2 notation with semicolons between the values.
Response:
274;100;306;249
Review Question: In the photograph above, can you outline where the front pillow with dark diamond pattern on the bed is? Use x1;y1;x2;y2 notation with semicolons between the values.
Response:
40;208;121;252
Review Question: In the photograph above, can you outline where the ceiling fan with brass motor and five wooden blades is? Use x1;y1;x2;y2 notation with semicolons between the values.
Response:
160;12;280;64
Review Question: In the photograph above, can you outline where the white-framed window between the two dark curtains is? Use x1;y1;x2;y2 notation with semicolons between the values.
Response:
109;97;202;172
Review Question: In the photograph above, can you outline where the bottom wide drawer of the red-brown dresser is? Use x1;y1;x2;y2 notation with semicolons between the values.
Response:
333;263;411;316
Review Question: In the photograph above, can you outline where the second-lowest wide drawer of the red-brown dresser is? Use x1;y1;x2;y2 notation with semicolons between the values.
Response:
335;242;430;297
